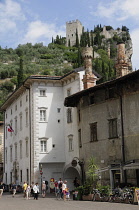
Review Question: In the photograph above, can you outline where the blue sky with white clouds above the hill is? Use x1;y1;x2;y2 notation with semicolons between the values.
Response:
0;0;139;70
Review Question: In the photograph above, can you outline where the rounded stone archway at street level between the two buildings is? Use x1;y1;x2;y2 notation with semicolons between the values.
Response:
63;165;81;191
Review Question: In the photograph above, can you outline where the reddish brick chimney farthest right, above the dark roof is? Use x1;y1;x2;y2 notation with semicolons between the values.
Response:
115;42;129;77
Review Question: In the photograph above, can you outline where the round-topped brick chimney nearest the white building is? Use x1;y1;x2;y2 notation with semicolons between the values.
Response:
82;46;97;89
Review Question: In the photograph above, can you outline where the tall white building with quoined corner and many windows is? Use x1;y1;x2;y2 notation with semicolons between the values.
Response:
1;68;91;190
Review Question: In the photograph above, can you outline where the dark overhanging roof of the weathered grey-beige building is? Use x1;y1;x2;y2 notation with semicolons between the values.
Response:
64;70;139;107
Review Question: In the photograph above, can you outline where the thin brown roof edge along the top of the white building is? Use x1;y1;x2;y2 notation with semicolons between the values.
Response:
0;67;101;111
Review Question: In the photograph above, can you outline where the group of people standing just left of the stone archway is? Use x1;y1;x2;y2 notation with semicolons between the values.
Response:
55;178;70;201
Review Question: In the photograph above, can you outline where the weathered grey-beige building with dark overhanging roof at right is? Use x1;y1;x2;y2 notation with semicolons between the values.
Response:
65;70;139;187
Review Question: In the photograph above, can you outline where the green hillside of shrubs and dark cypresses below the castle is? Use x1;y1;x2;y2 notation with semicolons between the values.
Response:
0;25;130;120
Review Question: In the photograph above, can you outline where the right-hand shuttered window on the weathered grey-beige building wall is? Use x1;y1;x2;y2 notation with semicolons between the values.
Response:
109;118;118;139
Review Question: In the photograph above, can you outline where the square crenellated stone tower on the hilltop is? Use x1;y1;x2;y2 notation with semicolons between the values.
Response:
66;20;83;47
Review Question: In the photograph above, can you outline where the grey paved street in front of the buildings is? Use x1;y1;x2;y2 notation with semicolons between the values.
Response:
0;194;139;210
